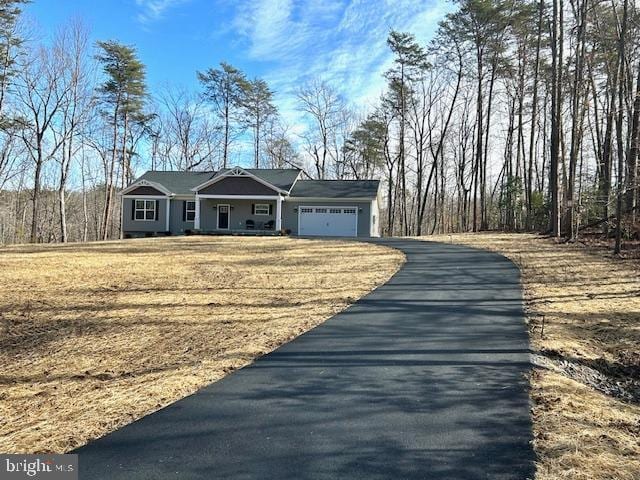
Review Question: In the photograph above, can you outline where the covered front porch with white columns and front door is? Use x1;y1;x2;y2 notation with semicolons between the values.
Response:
194;195;282;235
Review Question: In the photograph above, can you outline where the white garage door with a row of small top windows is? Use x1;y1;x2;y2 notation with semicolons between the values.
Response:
298;207;358;237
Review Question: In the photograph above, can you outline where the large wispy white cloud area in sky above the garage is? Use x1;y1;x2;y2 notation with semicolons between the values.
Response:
228;0;452;128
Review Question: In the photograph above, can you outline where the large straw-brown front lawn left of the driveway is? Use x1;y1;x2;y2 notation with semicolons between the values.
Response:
0;237;404;453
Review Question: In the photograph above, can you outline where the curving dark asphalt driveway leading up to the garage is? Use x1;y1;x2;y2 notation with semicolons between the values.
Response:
76;239;534;480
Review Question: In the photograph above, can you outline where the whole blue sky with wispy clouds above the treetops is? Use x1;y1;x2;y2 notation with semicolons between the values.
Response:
25;0;453;129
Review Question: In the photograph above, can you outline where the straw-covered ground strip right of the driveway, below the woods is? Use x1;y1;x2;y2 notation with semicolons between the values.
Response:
428;234;640;480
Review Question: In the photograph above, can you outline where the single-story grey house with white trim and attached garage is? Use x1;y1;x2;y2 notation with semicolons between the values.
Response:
121;167;380;237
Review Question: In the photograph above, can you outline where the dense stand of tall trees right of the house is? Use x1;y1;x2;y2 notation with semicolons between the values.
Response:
346;0;640;252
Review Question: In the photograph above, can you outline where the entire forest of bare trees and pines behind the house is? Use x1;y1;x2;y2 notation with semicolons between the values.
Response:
0;0;640;251
